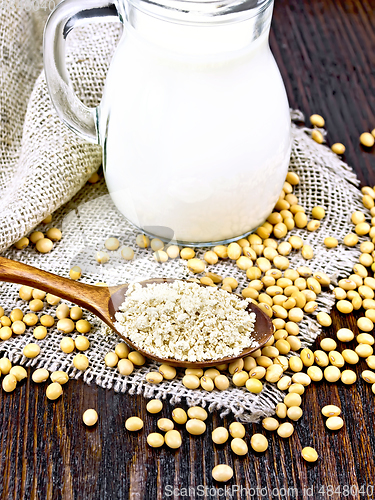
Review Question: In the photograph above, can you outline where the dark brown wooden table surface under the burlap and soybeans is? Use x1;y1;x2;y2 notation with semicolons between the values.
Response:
0;0;375;500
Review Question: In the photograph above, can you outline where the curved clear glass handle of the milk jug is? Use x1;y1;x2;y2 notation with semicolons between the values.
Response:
44;0;120;144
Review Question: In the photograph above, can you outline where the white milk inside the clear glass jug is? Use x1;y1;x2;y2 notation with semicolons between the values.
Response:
100;18;290;243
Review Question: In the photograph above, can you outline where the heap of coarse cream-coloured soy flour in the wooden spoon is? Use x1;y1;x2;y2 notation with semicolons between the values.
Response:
115;281;259;361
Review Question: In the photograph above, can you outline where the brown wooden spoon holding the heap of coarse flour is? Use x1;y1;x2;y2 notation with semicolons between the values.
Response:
0;257;273;368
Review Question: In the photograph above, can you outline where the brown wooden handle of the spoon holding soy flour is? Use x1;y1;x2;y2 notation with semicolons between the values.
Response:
0;257;109;317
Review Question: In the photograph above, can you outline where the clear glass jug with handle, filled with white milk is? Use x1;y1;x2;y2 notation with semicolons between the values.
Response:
44;0;291;245
